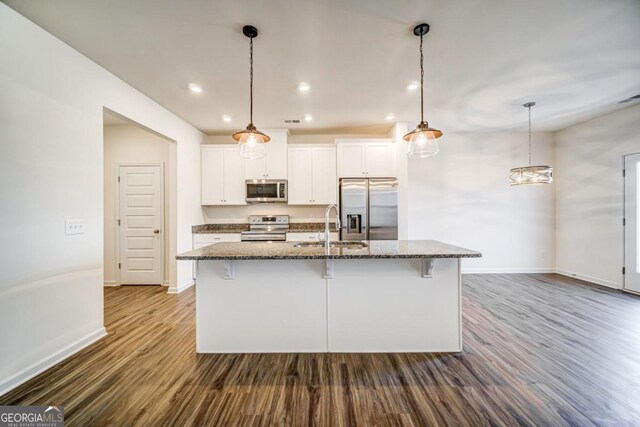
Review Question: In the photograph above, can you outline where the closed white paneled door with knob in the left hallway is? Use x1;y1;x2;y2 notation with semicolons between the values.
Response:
118;165;164;285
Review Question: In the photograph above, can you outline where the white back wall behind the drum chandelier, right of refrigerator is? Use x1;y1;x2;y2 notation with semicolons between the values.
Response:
408;132;555;273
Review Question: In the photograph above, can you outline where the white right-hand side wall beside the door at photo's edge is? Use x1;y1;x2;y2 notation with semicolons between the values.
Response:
554;105;640;288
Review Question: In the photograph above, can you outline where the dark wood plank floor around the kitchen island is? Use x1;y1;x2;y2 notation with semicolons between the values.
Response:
0;274;640;426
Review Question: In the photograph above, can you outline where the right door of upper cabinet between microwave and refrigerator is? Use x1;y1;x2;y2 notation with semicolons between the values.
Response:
310;147;337;205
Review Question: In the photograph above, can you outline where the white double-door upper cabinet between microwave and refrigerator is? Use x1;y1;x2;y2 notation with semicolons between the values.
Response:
288;145;337;205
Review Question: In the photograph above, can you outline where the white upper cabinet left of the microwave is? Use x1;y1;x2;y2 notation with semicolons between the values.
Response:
201;145;247;205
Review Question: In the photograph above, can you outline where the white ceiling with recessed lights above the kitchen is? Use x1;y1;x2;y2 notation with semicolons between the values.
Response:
3;0;640;135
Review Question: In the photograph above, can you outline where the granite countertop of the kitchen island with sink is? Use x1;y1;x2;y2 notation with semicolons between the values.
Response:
176;240;482;261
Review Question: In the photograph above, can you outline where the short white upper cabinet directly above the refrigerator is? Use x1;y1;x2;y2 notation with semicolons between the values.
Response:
336;139;396;178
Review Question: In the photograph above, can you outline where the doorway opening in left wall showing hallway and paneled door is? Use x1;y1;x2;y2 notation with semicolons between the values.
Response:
103;108;176;286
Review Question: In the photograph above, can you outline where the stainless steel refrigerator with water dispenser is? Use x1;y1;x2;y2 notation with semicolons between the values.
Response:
340;178;398;240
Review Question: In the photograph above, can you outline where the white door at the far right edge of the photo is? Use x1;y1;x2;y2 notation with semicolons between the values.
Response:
624;153;640;292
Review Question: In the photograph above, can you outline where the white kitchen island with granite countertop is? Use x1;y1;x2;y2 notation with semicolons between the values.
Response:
176;240;481;353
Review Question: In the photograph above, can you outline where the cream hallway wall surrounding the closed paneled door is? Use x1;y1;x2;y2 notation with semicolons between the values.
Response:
104;125;177;285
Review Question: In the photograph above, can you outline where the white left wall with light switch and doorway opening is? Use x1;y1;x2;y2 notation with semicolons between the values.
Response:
0;3;203;394
